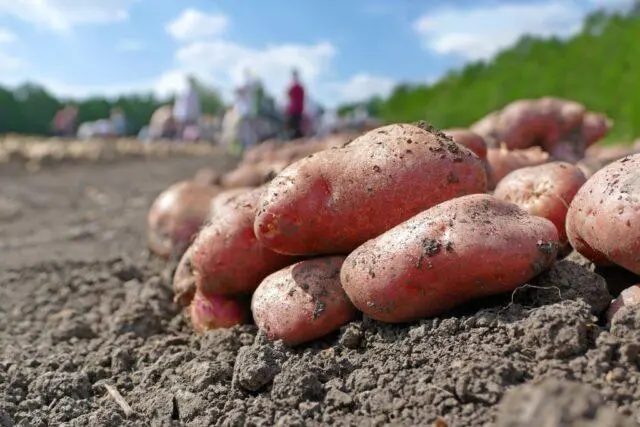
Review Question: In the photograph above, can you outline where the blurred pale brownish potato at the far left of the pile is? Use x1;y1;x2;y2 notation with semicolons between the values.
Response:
147;181;220;259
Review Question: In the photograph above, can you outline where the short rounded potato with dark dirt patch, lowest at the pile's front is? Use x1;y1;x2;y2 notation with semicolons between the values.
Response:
251;256;358;345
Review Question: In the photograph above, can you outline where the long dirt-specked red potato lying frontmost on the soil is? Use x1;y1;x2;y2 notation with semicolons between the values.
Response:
340;194;558;323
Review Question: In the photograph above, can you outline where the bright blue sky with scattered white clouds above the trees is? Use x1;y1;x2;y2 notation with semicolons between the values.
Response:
0;0;631;105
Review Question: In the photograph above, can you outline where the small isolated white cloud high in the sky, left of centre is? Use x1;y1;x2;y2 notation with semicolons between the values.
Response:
166;8;229;41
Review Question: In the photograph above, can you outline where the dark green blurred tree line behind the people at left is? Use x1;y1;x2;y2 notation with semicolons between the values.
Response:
0;80;224;135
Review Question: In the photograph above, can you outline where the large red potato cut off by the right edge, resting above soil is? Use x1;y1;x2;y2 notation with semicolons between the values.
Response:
566;154;640;274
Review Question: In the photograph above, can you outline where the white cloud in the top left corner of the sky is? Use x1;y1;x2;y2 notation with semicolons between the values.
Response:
0;0;139;33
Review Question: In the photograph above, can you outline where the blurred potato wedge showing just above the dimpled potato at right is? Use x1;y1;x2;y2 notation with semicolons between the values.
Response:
487;145;549;189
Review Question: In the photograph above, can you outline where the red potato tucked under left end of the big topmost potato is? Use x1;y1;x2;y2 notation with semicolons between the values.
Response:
192;188;297;295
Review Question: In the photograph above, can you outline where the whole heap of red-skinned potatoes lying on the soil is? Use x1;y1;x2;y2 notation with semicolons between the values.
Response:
149;98;640;345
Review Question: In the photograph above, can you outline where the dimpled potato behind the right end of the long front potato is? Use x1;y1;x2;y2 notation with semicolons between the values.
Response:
493;162;587;244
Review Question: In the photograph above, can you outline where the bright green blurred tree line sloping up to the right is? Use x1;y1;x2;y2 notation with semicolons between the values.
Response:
348;2;640;140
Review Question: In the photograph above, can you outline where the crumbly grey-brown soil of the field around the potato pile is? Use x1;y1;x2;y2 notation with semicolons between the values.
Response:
0;152;640;427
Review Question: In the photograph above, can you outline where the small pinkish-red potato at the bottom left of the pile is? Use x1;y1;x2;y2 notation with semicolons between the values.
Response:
188;291;249;332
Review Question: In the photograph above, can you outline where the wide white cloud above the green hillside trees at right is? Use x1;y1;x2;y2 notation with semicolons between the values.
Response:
414;0;588;60
